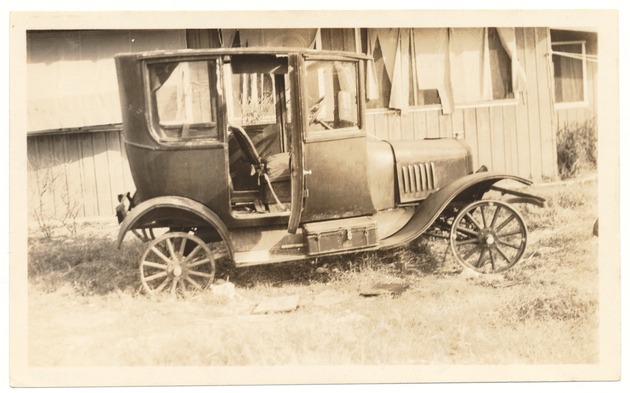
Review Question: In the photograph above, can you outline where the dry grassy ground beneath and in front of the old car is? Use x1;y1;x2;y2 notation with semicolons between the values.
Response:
28;178;599;366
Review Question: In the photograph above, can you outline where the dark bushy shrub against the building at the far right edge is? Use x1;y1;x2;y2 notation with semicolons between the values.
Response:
557;119;597;179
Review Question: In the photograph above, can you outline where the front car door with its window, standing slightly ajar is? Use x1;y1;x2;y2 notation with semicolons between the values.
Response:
290;56;375;229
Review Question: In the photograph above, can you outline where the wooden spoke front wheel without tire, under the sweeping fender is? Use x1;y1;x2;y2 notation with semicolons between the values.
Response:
450;200;527;273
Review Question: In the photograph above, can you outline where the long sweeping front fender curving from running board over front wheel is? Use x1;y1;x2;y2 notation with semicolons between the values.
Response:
381;172;532;248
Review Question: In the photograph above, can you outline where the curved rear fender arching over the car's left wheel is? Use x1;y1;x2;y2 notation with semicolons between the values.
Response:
117;196;233;257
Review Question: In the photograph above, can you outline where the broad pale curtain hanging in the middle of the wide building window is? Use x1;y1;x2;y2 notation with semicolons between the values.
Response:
413;28;454;114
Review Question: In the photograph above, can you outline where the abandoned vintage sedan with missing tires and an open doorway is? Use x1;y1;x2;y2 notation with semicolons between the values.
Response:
116;48;544;293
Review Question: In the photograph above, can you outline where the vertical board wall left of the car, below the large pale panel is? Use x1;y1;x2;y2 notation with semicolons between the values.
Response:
27;130;135;219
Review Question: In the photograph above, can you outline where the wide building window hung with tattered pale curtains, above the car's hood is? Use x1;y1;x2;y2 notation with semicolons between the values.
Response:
364;28;524;113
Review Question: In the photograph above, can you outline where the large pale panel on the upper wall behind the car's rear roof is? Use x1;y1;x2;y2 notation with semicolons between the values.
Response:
26;30;186;132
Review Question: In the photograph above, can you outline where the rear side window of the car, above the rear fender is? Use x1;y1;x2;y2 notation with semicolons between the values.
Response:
149;60;217;141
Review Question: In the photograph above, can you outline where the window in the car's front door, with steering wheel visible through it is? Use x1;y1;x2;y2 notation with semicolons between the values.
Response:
305;60;359;134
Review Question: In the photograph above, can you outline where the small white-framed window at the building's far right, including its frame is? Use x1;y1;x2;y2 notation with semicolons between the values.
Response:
551;41;586;106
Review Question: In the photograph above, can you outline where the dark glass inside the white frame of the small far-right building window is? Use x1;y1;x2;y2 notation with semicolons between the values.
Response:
553;44;584;102
